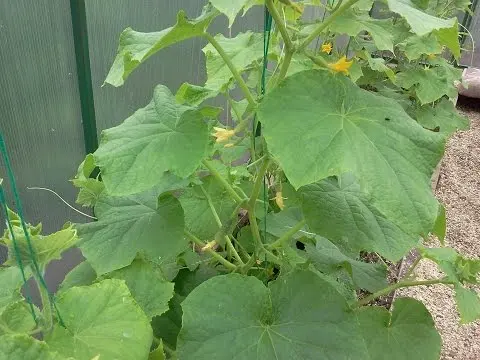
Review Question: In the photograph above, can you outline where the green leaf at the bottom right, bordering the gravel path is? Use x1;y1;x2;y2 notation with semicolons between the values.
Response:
354;298;442;360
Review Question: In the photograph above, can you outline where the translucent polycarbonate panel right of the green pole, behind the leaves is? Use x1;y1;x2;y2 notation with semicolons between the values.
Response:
86;0;263;134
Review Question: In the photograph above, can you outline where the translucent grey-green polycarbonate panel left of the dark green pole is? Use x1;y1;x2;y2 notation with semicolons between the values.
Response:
0;0;85;283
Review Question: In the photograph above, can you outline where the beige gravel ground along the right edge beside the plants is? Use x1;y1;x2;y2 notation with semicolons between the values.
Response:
396;98;480;360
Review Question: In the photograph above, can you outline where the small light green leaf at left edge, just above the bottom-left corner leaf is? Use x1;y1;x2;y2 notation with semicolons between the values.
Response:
0;300;36;335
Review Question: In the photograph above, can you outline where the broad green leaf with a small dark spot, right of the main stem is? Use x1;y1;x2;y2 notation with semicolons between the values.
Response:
258;70;444;240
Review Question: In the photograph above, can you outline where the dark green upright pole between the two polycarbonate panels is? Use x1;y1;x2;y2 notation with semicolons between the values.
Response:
70;0;98;154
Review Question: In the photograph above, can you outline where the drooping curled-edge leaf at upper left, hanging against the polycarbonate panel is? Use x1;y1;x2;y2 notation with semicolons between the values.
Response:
105;5;218;86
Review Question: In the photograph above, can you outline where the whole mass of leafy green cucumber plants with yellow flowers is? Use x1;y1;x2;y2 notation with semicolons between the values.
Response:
0;0;480;360
